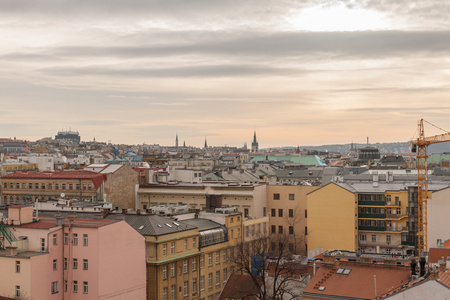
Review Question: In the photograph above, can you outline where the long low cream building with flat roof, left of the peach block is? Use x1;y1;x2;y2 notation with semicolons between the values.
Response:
138;183;266;218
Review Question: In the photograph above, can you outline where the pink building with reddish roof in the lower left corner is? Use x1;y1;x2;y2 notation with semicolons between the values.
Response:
0;206;146;300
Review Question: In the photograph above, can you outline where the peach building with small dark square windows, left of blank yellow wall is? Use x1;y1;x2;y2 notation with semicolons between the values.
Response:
266;184;318;255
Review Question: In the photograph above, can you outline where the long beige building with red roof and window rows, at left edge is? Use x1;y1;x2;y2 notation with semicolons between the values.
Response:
1;171;107;205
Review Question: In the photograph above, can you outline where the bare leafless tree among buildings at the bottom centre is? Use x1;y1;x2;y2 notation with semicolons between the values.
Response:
230;235;309;300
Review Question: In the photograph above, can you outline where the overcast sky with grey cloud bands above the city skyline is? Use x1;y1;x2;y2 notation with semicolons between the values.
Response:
0;0;450;147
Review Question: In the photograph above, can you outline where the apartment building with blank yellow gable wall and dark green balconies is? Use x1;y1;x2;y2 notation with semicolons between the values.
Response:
307;176;447;256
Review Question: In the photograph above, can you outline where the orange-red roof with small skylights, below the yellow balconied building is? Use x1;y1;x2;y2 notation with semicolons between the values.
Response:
304;261;410;299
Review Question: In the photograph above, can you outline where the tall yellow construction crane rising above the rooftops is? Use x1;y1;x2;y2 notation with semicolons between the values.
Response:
411;119;450;256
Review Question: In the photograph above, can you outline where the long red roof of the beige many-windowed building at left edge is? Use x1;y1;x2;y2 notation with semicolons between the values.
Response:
2;171;107;189
